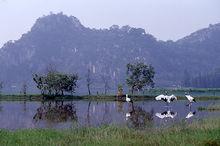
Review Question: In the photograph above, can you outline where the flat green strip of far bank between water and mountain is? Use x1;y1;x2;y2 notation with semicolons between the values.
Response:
0;88;220;101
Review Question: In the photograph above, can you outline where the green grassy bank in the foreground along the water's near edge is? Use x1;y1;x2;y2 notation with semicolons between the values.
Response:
0;119;220;146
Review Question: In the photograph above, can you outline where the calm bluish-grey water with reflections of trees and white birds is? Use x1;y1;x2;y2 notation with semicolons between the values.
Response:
0;100;220;130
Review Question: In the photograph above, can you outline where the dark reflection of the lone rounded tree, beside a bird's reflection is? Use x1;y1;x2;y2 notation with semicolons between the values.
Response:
126;104;154;128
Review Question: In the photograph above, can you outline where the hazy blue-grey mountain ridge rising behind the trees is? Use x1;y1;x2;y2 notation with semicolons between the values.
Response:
0;13;220;93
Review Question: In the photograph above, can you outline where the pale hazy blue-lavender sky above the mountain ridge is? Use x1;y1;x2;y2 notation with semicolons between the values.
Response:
0;0;220;47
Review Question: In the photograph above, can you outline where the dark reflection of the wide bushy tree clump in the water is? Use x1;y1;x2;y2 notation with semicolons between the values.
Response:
33;101;77;122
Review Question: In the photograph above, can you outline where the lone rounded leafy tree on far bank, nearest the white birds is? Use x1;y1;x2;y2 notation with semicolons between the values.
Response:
126;62;155;94
